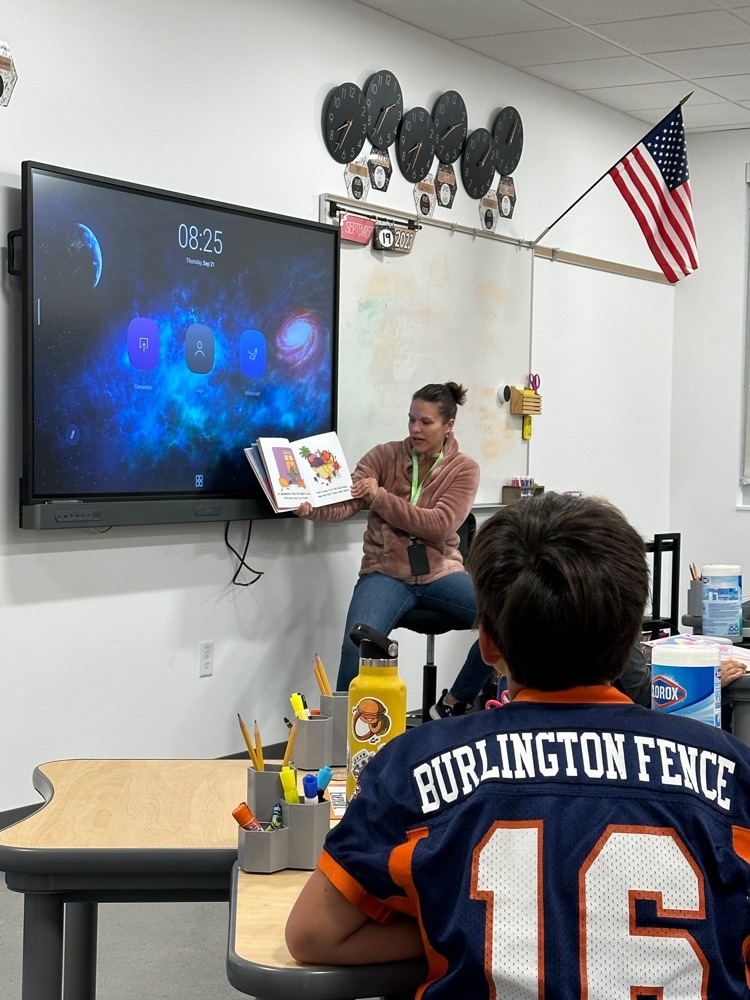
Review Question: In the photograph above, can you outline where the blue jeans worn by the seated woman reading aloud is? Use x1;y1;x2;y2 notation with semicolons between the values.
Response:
336;573;490;701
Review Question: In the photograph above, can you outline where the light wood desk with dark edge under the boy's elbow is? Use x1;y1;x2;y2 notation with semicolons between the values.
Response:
227;865;427;1000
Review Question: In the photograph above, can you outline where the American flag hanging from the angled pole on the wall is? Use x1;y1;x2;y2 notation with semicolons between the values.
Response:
609;105;698;284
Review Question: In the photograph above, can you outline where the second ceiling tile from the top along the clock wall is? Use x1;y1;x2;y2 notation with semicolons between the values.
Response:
460;28;622;68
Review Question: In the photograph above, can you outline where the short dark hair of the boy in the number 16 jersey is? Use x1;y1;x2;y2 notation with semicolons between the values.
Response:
467;493;649;691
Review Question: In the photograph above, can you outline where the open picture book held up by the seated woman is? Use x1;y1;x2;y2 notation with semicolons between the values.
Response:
245;431;352;514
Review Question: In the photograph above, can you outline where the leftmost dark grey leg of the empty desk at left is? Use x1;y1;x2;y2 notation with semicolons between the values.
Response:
21;892;63;1000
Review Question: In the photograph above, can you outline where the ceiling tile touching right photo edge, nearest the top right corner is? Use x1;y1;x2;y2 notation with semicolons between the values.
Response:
591;10;750;53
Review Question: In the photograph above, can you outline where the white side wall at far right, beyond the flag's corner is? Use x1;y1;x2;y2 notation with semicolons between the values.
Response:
671;131;750;576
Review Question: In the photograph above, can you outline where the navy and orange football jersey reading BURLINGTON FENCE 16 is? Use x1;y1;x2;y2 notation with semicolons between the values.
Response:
319;686;750;1000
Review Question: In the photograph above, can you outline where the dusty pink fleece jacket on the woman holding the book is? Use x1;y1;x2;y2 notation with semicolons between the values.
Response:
311;434;479;583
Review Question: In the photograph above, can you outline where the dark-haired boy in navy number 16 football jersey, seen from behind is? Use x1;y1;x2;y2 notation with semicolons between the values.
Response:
287;494;750;1000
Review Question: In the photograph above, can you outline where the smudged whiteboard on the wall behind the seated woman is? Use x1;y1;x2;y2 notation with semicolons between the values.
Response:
338;226;532;503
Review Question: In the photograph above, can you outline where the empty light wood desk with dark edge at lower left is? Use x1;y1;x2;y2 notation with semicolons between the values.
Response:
0;760;248;1000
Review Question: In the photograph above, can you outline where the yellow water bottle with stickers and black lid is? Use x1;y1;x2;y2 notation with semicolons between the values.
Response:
346;625;406;802
